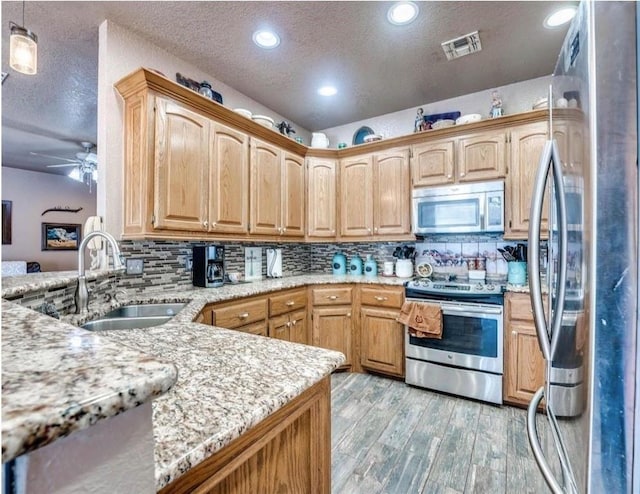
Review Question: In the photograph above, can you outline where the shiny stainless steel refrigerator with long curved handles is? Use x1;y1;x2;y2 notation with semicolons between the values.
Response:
527;1;640;494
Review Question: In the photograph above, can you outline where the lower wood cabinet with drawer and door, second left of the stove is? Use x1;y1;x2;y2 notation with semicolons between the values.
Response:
311;286;355;369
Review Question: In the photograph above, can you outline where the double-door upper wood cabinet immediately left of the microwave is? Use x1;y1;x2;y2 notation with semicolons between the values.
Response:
340;149;411;237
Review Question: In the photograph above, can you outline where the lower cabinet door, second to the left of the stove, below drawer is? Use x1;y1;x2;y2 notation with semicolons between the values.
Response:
311;306;352;367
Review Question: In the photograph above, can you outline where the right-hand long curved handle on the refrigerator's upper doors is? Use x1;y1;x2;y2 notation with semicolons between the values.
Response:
550;139;568;361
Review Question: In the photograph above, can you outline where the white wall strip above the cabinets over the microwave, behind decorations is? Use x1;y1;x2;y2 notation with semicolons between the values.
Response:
321;75;551;148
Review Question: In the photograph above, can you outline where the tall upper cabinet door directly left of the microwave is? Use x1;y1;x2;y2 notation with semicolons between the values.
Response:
373;149;411;235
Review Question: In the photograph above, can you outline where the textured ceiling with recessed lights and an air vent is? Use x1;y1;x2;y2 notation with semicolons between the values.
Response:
2;1;575;178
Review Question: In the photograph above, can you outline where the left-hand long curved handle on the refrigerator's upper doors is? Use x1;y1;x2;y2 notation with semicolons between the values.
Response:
527;140;553;362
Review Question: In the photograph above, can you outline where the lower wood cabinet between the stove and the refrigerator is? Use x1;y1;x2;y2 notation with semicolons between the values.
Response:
504;293;545;406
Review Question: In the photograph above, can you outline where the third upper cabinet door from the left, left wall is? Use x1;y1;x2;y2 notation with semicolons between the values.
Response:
249;138;282;235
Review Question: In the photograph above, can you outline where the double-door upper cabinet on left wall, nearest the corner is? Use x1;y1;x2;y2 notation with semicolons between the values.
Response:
249;139;305;237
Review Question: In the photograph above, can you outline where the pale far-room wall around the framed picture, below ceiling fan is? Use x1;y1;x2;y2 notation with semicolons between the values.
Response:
2;166;96;271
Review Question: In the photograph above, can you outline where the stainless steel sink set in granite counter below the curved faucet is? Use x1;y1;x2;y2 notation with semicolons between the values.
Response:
82;303;187;331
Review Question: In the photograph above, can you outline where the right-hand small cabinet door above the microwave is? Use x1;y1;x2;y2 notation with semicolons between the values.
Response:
456;130;507;182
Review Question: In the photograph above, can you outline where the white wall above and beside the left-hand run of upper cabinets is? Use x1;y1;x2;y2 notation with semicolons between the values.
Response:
98;20;311;238
